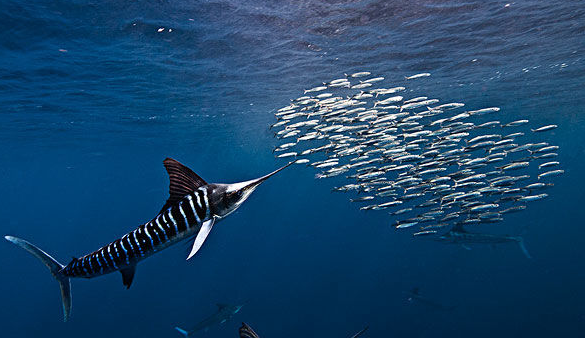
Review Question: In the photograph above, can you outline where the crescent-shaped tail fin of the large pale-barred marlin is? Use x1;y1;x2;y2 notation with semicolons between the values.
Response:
4;236;71;322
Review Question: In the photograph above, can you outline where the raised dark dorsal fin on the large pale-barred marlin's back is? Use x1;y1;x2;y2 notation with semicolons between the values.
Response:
160;158;207;212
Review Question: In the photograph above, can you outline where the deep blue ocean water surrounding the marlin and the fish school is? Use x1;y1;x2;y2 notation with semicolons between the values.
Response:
0;0;585;337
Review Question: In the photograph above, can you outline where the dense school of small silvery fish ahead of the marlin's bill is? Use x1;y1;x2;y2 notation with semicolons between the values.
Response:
270;72;564;236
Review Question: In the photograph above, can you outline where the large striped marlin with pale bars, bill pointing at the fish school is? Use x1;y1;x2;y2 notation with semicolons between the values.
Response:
4;158;293;321
